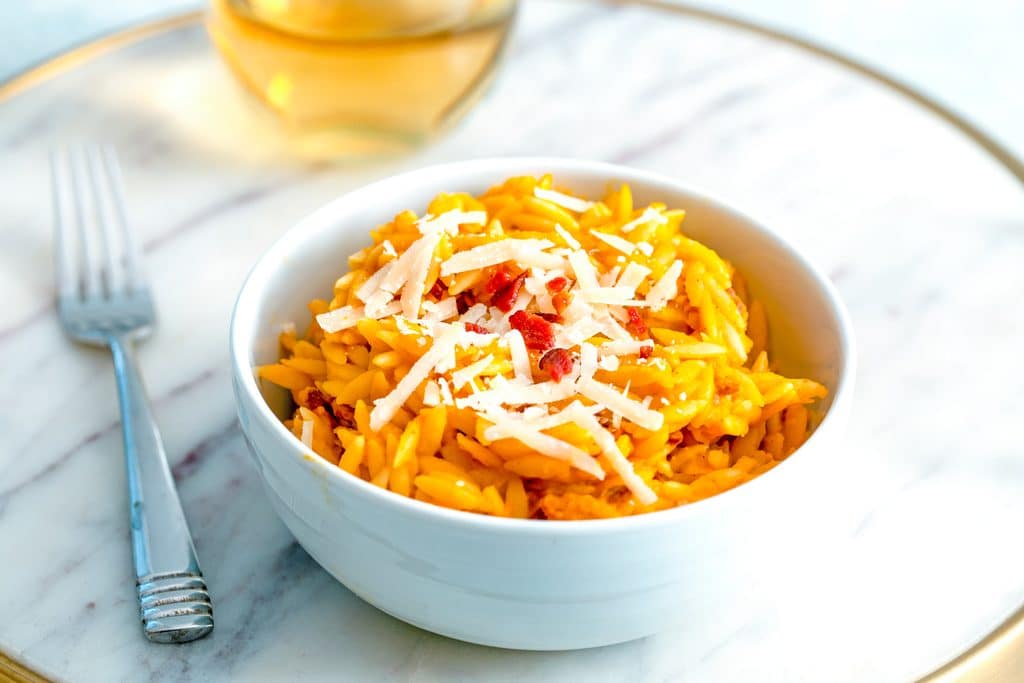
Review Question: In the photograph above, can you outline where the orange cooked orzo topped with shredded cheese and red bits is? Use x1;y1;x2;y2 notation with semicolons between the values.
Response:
259;175;825;519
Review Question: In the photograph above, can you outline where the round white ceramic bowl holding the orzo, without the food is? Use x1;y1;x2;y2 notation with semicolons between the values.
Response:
230;159;855;650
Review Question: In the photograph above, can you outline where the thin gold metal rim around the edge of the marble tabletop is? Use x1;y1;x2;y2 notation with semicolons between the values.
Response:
0;0;1024;683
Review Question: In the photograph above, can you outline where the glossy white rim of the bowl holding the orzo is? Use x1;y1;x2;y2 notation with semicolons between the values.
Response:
228;157;857;536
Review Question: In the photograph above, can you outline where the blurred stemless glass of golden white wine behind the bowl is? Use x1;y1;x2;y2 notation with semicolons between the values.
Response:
207;0;517;157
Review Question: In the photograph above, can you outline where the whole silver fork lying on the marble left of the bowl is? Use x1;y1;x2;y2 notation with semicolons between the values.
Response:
50;146;213;643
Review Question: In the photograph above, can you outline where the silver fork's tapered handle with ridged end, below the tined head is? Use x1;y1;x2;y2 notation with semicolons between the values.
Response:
110;336;213;643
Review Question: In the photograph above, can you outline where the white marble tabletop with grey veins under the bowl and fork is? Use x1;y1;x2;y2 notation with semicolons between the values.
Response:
0;4;1024;682
